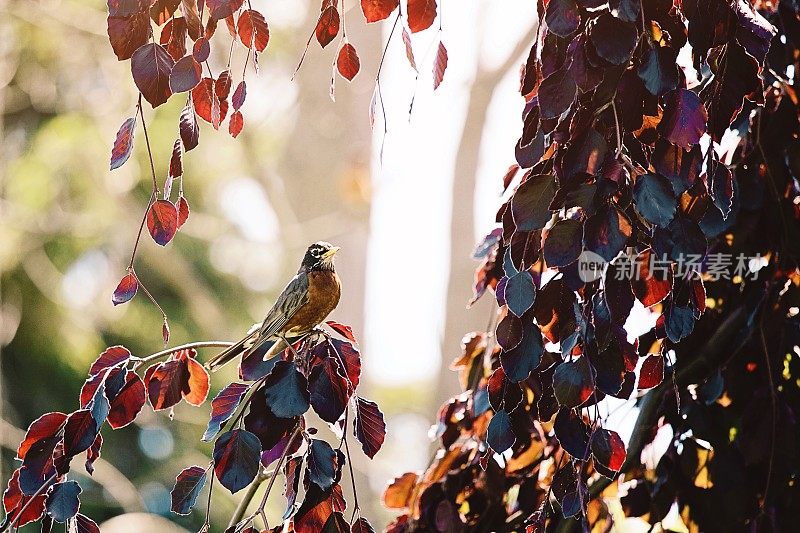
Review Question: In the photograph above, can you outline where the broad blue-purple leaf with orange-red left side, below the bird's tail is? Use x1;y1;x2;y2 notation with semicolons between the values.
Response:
214;429;261;493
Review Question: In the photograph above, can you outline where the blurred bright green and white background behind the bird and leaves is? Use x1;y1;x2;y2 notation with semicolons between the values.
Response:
0;0;534;531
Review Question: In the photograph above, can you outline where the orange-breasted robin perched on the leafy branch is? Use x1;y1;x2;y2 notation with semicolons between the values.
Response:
206;241;342;371
